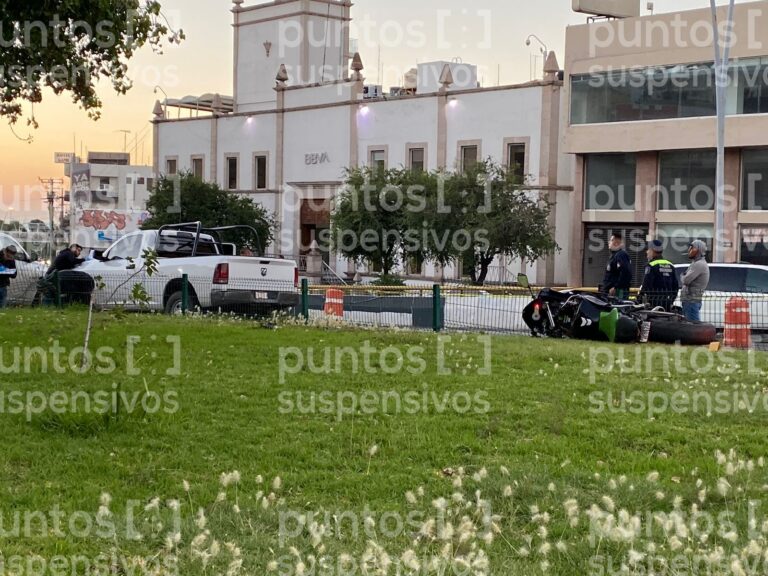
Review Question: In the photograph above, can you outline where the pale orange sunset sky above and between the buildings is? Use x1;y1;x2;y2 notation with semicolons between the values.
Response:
0;0;748;220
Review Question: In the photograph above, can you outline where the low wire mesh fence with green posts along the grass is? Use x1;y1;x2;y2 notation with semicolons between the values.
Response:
7;268;768;343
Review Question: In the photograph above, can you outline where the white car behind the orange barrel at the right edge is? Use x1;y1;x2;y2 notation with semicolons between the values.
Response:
675;264;768;332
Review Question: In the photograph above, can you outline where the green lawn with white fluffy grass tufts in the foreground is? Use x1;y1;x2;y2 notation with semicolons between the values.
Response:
0;310;768;576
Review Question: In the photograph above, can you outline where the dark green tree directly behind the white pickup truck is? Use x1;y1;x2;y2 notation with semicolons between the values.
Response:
142;173;275;254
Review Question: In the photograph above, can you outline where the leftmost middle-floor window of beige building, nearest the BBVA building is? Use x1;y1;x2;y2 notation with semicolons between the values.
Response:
584;154;637;210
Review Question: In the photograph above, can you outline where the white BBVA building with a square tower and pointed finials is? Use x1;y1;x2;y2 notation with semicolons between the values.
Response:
154;0;572;283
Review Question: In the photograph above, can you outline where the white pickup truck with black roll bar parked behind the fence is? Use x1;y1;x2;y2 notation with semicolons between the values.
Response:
70;223;300;314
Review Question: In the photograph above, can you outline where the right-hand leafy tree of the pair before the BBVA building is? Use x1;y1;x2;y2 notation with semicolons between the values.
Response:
426;160;558;286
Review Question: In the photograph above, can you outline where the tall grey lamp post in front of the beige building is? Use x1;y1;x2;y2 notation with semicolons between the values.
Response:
710;0;735;262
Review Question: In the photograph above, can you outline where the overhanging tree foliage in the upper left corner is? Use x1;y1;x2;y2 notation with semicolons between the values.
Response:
0;0;184;127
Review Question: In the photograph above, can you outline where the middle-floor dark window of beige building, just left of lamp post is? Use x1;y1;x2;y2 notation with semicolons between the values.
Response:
659;150;717;210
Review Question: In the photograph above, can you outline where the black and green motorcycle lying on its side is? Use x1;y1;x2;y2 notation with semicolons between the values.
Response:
518;274;717;345
